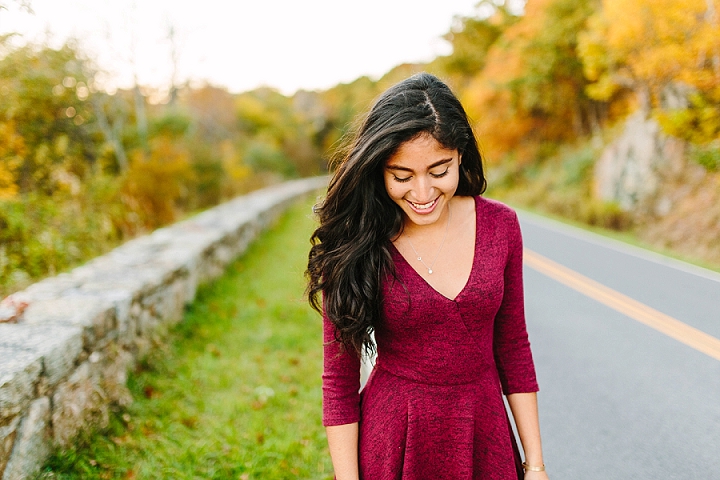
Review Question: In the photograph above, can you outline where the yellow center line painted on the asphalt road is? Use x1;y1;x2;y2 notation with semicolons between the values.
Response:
523;248;720;360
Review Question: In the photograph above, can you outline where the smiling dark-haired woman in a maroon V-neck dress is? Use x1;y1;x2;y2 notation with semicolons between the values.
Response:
308;73;548;480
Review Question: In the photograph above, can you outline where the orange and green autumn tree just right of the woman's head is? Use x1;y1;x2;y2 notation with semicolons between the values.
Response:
462;0;599;161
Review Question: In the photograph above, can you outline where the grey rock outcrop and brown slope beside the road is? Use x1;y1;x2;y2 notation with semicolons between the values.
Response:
593;112;720;265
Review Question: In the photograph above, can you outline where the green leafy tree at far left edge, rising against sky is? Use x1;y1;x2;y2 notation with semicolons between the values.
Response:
0;38;98;194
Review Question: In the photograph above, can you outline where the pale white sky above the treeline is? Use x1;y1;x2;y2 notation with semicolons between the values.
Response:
0;0;490;94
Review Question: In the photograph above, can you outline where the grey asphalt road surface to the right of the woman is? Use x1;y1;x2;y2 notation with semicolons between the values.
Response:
520;212;720;480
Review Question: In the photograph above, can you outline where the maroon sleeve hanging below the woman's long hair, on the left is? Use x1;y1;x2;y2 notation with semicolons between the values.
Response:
322;315;360;426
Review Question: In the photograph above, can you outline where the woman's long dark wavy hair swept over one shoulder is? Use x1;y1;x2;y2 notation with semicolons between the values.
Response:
306;73;486;355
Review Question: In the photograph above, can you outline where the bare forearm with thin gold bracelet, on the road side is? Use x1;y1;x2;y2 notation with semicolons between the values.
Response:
507;392;548;480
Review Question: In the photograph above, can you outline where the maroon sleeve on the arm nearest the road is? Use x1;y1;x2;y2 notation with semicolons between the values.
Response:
493;212;538;395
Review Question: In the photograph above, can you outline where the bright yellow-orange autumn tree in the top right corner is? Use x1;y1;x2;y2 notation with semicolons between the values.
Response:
580;0;720;143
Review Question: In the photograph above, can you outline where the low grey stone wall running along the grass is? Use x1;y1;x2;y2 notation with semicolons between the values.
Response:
0;178;327;480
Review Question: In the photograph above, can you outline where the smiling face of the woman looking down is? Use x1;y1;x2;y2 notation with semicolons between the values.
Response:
384;135;461;226
